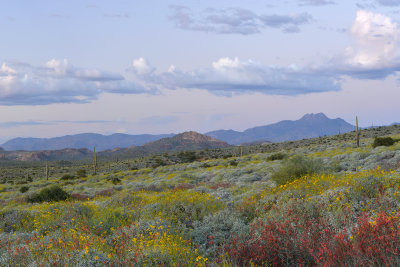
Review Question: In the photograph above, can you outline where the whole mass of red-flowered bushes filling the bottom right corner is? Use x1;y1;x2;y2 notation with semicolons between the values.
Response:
225;214;400;266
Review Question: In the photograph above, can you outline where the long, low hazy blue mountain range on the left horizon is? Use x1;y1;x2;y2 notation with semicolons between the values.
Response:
1;133;173;151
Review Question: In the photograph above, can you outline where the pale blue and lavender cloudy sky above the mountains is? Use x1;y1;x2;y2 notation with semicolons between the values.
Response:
0;0;400;142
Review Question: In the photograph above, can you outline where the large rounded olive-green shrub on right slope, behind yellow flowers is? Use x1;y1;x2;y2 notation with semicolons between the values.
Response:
272;156;323;185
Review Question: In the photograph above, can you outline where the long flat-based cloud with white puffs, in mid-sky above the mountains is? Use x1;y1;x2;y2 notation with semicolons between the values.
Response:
132;58;340;95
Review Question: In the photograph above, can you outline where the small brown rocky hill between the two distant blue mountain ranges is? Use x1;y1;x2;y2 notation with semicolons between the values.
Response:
142;131;229;152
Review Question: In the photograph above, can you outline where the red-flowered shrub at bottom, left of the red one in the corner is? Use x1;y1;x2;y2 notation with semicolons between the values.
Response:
225;216;335;266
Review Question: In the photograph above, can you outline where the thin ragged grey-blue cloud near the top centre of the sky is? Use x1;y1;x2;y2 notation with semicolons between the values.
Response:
169;6;312;35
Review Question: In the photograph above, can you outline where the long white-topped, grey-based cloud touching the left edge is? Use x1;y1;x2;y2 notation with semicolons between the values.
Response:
0;59;154;105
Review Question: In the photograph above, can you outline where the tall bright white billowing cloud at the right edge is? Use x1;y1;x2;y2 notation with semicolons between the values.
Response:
333;10;400;79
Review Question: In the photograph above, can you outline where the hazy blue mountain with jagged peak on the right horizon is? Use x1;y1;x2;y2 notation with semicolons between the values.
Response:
206;113;355;145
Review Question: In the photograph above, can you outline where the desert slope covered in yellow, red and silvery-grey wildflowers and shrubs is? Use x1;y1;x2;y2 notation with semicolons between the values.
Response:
0;133;400;266
